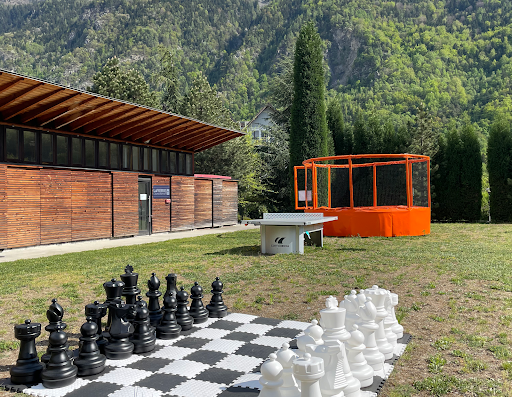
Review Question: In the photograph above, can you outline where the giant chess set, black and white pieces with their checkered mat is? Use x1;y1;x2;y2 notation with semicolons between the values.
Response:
0;266;410;397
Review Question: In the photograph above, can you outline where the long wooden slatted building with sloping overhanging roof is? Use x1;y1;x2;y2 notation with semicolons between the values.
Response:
0;69;242;249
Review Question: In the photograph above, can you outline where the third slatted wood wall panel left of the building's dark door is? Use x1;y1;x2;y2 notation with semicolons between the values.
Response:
39;168;71;244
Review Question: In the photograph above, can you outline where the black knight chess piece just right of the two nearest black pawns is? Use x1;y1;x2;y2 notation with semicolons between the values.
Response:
105;303;134;360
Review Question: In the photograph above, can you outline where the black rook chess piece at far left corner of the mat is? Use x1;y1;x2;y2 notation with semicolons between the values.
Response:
10;320;44;386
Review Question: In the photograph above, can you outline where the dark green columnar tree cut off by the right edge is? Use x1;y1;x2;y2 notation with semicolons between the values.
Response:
487;117;512;222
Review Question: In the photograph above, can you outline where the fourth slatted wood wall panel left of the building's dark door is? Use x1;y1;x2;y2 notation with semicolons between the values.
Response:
5;167;41;248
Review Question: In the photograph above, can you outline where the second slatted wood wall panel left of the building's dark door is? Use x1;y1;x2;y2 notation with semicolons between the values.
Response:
71;171;112;241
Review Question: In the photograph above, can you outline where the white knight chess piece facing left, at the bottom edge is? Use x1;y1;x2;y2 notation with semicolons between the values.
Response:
312;340;348;397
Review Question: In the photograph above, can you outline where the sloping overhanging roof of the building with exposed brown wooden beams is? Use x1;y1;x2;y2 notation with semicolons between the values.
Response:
0;69;244;152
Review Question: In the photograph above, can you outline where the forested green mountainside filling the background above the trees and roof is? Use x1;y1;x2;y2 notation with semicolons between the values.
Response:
0;0;512;135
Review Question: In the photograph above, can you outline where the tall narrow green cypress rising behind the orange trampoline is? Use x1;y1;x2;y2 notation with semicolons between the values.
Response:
290;22;328;202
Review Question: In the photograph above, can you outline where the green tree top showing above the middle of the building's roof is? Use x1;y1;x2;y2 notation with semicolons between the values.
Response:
89;57;158;107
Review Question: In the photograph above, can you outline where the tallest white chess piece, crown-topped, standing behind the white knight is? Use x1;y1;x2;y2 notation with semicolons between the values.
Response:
320;296;361;397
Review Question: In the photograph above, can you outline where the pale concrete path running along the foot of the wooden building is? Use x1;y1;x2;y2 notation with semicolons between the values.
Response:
0;224;258;263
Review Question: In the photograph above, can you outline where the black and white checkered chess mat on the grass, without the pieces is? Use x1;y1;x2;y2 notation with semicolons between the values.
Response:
0;313;410;397
